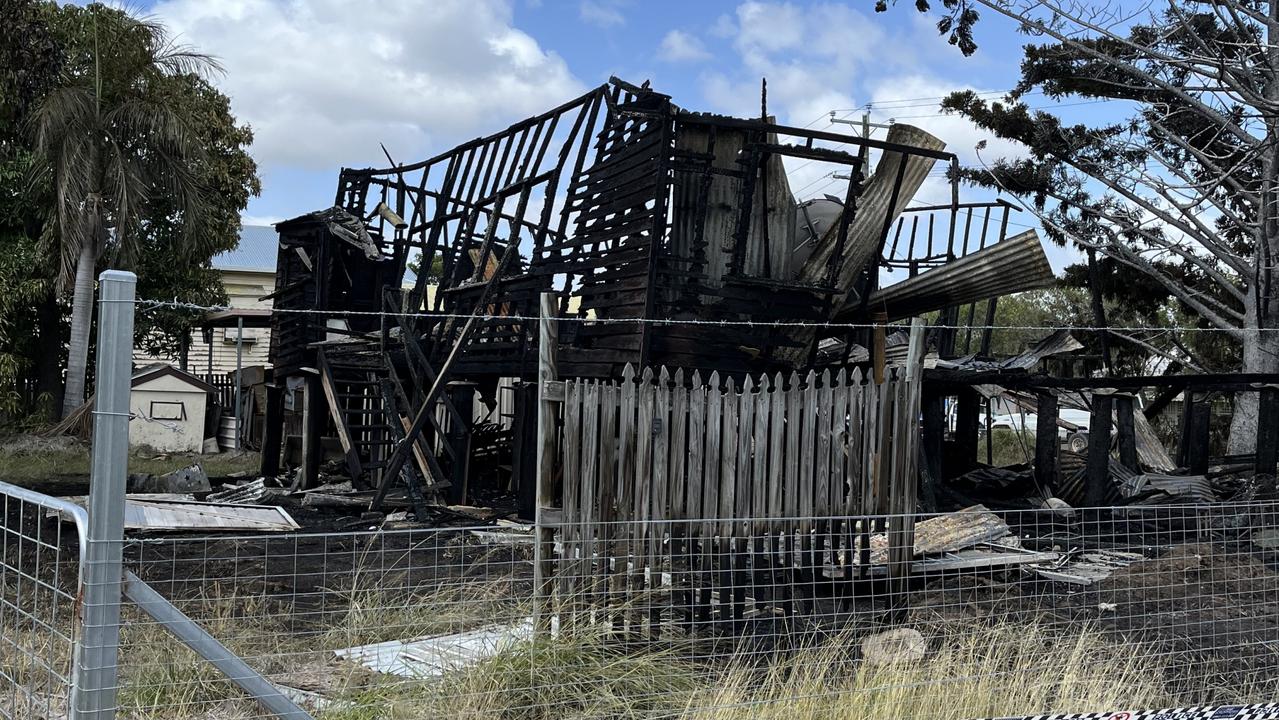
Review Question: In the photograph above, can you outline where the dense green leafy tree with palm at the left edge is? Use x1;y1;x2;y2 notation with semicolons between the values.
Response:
0;0;260;416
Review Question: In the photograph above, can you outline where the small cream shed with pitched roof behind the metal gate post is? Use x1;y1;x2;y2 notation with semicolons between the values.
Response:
129;364;214;453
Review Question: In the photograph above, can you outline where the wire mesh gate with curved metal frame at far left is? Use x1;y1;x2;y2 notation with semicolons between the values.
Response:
0;483;84;720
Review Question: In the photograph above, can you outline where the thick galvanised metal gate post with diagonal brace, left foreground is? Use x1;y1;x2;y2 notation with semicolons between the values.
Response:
70;270;137;720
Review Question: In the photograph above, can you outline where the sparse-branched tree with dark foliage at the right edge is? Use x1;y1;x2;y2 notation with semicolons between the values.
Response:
880;0;1279;451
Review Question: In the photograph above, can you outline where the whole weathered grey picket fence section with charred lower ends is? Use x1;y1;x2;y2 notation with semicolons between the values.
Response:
544;345;920;633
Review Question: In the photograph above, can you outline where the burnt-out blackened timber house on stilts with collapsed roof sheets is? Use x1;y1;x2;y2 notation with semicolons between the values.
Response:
263;78;1051;506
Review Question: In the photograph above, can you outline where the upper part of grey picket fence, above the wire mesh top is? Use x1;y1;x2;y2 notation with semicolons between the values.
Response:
560;366;918;534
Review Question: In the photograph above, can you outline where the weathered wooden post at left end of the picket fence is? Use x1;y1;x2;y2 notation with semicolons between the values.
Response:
533;293;559;630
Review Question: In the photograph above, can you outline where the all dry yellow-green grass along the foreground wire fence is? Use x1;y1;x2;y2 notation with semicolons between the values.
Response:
0;537;1238;720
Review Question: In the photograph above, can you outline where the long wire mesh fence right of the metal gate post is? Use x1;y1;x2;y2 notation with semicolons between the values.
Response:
74;503;1279;720
